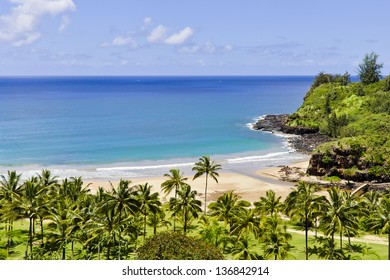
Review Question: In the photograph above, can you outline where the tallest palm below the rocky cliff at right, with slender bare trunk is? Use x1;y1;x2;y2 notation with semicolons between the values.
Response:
285;181;324;260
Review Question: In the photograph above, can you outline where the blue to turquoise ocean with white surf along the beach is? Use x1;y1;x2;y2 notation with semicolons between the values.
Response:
0;76;313;177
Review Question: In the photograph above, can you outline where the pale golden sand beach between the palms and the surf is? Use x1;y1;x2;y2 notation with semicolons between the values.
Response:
85;161;308;205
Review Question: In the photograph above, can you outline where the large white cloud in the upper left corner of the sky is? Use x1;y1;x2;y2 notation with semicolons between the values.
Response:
0;0;76;46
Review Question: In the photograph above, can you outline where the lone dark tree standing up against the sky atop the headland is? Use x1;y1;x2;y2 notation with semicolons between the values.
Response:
358;52;383;85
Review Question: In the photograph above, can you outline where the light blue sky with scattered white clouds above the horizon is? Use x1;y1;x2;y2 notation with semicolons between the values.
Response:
0;0;390;76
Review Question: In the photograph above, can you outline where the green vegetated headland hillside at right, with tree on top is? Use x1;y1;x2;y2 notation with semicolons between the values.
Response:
288;54;390;182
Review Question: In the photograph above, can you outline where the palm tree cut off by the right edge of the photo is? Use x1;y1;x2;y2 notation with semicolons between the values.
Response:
369;197;390;260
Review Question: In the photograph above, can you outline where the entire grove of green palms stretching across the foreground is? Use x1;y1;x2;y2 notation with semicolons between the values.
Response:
0;156;390;259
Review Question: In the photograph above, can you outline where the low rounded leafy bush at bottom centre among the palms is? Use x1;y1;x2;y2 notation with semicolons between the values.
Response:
137;232;224;260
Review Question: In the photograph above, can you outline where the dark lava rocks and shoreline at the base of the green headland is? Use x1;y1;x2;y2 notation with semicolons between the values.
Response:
253;114;390;191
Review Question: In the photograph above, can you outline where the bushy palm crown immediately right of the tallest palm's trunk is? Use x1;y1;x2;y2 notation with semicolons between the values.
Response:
209;191;251;233
